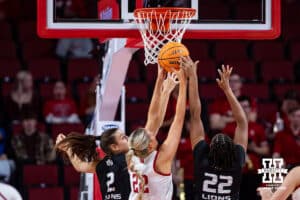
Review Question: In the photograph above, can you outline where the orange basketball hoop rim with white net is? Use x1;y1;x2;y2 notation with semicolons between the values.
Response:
134;7;196;65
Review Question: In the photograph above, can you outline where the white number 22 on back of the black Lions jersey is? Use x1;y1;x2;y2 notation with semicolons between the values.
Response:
202;173;232;194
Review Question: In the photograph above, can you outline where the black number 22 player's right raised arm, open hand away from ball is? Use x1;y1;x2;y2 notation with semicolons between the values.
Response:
217;65;248;152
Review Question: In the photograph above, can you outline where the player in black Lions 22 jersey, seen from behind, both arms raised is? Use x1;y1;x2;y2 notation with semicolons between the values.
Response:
183;58;248;200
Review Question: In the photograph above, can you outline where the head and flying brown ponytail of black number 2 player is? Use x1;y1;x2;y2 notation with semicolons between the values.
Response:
55;128;129;162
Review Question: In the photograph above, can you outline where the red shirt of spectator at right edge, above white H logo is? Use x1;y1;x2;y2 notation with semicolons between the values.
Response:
274;128;300;165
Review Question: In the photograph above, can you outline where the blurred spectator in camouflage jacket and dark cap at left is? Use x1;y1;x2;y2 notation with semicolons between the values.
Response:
12;113;55;164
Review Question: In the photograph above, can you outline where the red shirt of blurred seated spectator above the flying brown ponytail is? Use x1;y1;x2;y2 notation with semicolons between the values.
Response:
44;98;77;117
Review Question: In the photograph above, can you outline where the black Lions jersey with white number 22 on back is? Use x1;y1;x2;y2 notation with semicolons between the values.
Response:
193;140;245;200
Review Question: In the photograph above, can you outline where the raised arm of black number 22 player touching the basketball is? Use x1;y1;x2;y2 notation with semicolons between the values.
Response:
182;57;205;149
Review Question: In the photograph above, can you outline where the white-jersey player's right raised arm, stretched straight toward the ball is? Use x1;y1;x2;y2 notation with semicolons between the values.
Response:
155;68;187;174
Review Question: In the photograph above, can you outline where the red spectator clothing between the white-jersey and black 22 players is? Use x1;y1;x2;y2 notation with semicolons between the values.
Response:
177;138;194;180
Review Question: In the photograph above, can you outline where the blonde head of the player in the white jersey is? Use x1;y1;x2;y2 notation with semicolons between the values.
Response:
128;128;158;158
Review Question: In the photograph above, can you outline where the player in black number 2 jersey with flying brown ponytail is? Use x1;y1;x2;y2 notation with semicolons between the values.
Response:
56;67;176;199
